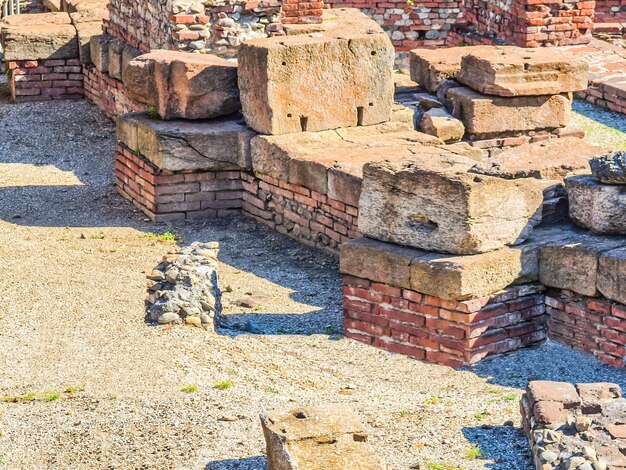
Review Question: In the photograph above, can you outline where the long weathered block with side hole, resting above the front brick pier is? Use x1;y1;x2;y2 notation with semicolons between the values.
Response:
359;160;543;255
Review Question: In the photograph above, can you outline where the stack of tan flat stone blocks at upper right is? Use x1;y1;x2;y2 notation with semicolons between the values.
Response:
411;46;588;147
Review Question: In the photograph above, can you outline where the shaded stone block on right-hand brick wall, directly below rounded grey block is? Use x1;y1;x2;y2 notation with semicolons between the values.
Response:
539;230;626;297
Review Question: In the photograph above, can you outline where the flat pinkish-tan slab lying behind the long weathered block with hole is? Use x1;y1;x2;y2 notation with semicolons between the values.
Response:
471;137;605;180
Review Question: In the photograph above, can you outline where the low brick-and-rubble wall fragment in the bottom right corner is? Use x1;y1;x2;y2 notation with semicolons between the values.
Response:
521;381;626;470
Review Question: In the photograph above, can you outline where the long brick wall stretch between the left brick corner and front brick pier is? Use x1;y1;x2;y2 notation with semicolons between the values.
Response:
242;174;361;254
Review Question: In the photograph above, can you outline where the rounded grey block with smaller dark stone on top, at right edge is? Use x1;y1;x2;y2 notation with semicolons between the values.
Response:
566;152;626;235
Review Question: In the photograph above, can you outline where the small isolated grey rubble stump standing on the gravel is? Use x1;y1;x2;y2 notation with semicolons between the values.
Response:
147;242;221;329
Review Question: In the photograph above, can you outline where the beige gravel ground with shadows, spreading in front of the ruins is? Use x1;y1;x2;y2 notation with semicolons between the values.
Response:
0;97;626;470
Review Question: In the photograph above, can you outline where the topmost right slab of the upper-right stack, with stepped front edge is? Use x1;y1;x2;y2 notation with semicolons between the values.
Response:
457;46;589;96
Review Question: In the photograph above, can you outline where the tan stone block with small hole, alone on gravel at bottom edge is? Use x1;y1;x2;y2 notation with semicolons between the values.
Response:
261;405;387;470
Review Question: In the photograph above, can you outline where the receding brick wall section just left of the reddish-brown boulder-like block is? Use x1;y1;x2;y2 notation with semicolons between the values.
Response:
83;64;145;119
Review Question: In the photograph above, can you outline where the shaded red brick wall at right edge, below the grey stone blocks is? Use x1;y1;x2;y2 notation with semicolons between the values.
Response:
545;290;626;367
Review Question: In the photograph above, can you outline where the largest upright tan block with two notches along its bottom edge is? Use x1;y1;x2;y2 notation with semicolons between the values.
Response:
238;9;395;134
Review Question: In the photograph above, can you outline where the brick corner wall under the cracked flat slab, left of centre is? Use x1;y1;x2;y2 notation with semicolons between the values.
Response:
115;144;243;221
